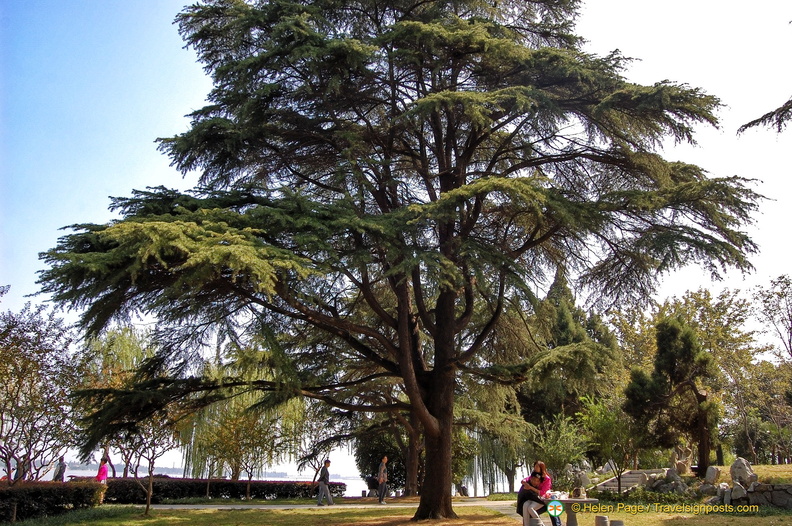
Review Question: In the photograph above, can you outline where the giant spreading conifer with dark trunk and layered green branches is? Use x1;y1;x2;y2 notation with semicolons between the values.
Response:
41;0;758;519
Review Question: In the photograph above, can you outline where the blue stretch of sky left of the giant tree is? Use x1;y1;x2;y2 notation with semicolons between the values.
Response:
0;0;211;309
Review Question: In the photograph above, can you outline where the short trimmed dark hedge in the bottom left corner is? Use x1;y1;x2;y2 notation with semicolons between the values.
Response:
0;482;107;522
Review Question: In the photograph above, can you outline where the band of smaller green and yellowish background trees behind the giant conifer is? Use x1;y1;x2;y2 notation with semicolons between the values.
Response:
6;278;792;493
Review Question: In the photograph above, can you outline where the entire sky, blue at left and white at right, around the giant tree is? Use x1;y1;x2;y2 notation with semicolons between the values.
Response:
0;0;792;318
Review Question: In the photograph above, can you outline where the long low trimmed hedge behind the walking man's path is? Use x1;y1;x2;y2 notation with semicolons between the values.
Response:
70;476;346;504
